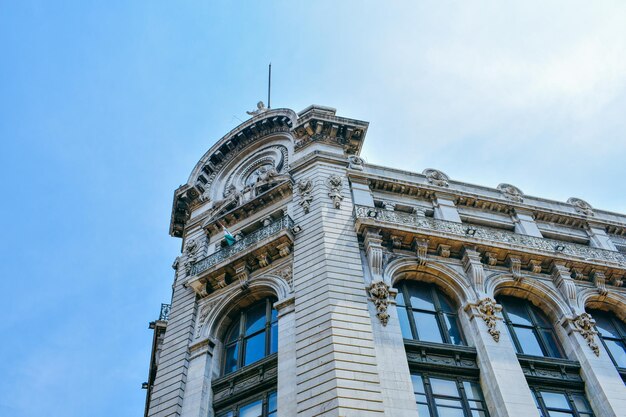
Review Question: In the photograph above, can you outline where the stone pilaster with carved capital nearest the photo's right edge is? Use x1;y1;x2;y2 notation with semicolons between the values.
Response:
562;313;626;417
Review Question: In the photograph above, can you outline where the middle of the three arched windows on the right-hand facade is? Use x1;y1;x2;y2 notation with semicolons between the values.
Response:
497;297;563;358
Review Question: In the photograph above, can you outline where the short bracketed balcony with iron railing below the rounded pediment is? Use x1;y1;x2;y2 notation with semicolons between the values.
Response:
187;215;294;296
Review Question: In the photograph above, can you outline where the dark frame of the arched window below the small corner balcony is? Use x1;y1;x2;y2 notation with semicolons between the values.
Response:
220;297;278;376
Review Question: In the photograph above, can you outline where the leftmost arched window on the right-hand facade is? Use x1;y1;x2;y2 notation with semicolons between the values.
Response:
396;281;465;345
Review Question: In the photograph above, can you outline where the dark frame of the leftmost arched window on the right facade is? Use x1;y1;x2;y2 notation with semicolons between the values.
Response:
394;280;467;346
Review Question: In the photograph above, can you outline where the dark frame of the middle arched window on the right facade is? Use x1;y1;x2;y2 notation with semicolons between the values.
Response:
496;295;567;359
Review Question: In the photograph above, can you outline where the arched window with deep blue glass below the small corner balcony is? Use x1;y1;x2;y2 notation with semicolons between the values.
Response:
222;298;278;375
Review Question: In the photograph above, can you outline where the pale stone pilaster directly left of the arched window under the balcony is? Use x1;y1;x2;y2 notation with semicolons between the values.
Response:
181;339;214;417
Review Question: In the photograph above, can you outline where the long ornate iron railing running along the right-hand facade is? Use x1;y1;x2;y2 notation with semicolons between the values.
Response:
355;206;626;267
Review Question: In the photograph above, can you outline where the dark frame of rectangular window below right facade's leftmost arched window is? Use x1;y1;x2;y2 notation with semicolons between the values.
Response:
411;370;490;417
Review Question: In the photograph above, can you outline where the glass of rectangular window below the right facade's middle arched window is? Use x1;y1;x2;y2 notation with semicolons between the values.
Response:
532;388;593;417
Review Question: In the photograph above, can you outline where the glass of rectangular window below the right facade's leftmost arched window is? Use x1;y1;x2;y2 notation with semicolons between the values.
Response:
411;373;489;417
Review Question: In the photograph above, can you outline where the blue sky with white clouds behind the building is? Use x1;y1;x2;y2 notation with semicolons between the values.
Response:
0;0;626;417
